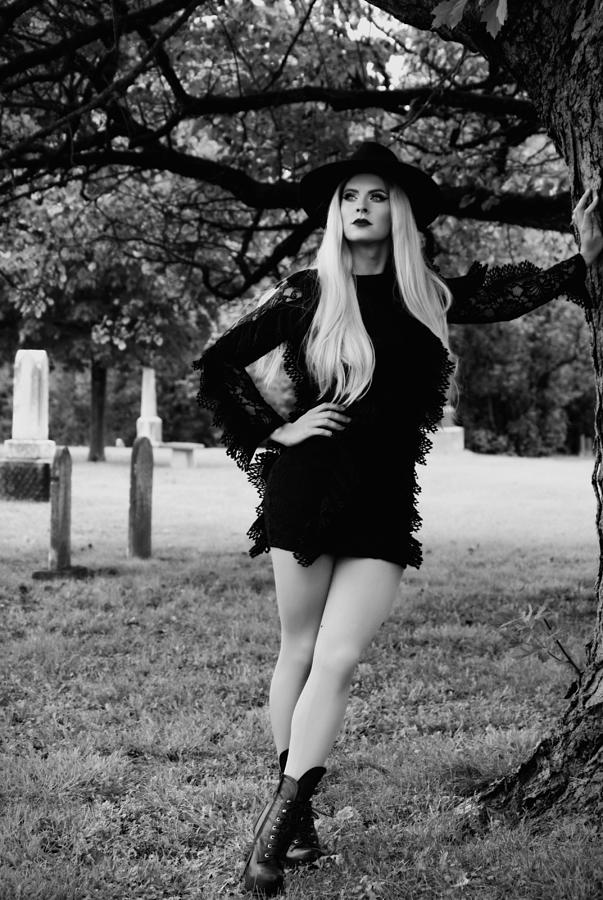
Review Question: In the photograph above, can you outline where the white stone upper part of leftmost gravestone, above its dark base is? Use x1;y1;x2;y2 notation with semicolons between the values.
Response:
5;350;56;459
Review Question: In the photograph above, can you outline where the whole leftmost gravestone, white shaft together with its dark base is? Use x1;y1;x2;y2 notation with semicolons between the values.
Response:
0;350;56;501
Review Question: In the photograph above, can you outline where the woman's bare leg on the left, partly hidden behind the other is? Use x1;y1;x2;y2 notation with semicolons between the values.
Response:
270;547;334;754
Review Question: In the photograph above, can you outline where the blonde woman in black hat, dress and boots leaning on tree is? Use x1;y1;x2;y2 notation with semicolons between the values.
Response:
194;142;603;895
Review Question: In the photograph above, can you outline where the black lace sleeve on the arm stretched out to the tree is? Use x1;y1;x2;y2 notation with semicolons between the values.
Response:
445;253;590;324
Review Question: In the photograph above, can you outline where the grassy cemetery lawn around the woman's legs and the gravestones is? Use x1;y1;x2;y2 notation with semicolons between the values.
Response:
0;450;603;900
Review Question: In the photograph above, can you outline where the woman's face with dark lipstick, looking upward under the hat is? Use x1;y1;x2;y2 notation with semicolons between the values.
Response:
341;174;392;243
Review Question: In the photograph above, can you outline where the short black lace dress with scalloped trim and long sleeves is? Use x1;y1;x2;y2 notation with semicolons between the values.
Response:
193;254;589;568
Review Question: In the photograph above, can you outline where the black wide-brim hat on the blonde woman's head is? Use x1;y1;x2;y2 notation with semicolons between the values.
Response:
299;141;444;229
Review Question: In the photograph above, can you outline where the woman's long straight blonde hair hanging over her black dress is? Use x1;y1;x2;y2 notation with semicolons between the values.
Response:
255;179;458;405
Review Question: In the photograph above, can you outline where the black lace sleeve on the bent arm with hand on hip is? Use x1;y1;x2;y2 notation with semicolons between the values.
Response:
193;280;302;472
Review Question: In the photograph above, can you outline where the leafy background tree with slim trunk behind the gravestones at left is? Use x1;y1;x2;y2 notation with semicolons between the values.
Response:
0;184;212;460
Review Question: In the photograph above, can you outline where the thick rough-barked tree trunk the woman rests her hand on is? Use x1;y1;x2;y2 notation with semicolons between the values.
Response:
373;0;603;819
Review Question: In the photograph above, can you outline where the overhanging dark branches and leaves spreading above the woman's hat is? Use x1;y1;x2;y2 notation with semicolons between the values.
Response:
0;0;580;260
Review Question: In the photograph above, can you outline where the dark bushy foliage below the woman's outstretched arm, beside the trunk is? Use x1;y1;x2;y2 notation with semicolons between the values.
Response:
454;300;595;456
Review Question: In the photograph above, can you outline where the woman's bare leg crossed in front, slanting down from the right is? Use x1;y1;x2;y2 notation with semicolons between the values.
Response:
285;557;404;779
